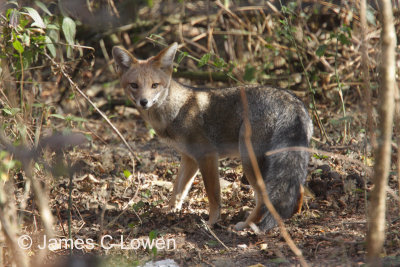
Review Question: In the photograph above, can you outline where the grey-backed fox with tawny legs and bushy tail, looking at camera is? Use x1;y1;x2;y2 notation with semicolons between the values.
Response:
112;42;313;232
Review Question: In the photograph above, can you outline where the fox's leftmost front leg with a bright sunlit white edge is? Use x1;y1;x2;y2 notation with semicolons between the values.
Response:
168;155;199;211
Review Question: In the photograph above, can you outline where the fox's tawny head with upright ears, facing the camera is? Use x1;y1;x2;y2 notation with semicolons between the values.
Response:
112;43;178;109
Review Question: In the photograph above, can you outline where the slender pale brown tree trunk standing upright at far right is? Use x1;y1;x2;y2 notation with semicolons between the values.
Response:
367;0;396;266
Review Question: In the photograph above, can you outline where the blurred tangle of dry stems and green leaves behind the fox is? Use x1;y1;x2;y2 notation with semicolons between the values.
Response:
0;0;400;266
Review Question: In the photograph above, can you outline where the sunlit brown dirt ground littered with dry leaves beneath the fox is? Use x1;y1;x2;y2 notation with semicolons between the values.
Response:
11;78;400;266
